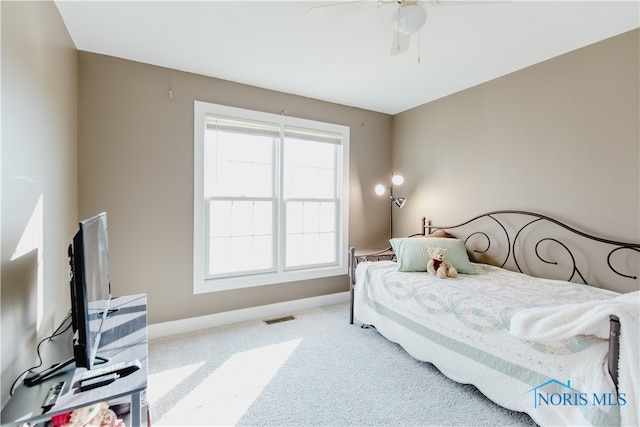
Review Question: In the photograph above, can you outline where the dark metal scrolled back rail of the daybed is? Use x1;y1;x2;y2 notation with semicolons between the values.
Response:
423;210;640;292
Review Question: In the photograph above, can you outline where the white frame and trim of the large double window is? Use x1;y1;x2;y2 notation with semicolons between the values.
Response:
193;101;350;294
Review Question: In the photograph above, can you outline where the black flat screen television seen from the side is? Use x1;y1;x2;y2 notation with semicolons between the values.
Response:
24;212;111;386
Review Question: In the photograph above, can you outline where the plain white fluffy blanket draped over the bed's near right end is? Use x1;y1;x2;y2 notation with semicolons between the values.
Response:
510;292;640;426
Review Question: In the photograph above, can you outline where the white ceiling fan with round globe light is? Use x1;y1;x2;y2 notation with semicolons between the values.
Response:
311;0;508;56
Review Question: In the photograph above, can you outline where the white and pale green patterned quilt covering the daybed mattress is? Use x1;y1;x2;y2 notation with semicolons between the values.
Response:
354;261;637;425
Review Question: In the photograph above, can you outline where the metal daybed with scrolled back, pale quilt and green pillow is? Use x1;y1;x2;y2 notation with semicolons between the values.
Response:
350;210;640;426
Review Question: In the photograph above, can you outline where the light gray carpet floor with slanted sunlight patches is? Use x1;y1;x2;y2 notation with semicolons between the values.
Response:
147;303;535;426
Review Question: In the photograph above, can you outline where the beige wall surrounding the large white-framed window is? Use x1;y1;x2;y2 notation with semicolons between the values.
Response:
78;52;391;323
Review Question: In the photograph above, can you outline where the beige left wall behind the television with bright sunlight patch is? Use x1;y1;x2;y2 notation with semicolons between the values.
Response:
0;1;77;405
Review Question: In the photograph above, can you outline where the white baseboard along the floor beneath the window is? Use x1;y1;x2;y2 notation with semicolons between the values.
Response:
147;292;349;340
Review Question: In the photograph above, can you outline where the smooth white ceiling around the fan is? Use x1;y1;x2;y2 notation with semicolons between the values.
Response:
56;0;640;114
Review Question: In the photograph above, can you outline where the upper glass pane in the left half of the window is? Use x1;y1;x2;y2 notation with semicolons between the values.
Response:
204;128;274;197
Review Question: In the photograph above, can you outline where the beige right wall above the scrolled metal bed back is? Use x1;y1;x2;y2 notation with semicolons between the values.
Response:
393;30;640;290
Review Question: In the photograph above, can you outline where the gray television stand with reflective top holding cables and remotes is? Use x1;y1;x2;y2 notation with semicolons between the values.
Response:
0;294;148;426
